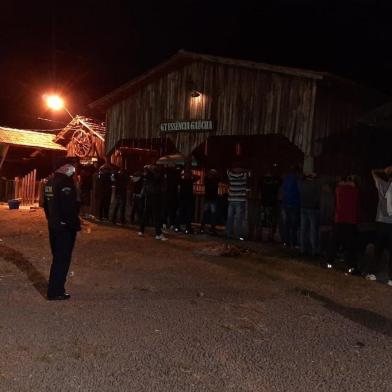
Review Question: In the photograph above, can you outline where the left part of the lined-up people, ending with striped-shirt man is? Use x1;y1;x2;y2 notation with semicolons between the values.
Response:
93;163;249;240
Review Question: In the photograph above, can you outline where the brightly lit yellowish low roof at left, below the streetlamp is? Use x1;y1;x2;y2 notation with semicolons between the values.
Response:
0;127;65;150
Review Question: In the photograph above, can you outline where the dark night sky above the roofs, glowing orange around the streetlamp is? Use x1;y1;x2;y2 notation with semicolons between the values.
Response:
0;0;392;128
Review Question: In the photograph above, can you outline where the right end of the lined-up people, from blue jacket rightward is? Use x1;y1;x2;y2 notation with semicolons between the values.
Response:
280;167;392;286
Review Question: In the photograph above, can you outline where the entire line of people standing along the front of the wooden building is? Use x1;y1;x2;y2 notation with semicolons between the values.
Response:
93;162;392;285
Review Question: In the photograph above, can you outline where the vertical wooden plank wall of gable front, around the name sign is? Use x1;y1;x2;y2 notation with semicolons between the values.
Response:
106;62;316;154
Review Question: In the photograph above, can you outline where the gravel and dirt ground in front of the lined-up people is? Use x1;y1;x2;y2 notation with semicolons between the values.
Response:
0;206;392;392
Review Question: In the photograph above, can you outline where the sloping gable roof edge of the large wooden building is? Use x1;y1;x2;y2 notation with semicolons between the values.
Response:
89;50;359;110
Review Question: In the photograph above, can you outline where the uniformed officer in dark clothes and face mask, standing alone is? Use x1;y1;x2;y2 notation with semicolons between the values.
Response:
44;160;80;300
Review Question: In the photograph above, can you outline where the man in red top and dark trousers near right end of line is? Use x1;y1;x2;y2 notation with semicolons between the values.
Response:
327;176;360;275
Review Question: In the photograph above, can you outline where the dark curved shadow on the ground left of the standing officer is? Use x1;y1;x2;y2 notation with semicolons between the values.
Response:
0;245;48;298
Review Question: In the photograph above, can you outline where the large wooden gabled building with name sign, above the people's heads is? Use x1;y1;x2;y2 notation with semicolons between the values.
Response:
91;51;383;175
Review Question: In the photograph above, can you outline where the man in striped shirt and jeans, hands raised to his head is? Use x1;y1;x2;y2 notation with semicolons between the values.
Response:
226;162;248;240
